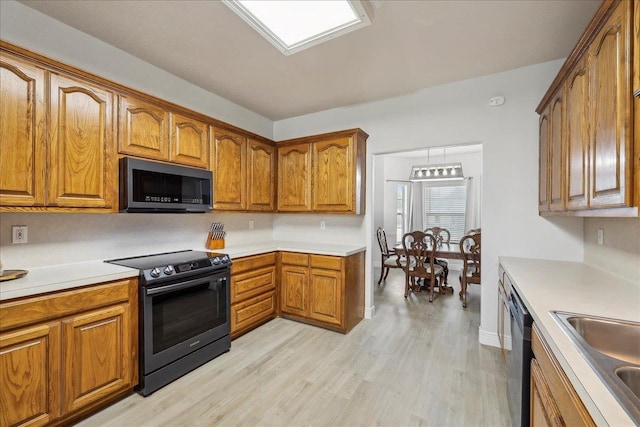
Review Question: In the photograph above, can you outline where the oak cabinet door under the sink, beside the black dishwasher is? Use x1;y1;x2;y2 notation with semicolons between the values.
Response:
529;359;565;427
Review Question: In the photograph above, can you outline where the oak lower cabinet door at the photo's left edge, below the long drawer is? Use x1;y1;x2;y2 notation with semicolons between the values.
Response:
0;323;60;426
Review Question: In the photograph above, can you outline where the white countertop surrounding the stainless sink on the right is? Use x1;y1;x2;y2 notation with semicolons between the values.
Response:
500;257;640;426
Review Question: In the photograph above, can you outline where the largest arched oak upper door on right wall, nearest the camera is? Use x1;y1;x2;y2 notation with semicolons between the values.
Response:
589;2;633;208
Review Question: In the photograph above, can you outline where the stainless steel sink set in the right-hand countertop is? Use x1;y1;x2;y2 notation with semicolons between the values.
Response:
551;311;640;425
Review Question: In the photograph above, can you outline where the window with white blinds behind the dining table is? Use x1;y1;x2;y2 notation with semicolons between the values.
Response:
423;184;467;243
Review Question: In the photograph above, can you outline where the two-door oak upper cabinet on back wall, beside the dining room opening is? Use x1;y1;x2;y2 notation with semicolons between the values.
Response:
278;129;368;215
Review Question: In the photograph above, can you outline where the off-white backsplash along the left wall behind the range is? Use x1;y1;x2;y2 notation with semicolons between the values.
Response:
0;213;273;270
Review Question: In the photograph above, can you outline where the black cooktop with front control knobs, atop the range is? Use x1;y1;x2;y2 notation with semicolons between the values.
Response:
105;250;231;283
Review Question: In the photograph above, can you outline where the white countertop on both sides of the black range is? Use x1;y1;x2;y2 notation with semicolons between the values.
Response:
0;241;366;301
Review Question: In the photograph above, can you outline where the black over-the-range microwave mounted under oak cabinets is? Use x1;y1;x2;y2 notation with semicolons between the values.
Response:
120;157;213;213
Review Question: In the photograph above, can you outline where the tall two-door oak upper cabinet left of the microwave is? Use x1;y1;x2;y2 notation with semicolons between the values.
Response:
0;51;117;212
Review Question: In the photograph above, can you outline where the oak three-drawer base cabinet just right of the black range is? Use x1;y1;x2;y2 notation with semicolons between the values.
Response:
231;252;277;338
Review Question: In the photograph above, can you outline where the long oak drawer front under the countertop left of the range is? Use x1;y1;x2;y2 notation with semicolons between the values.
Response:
0;280;131;331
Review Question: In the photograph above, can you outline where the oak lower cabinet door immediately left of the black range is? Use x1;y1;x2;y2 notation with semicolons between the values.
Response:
62;303;132;411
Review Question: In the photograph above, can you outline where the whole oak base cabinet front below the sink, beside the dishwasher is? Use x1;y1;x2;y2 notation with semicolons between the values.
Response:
530;323;595;427
